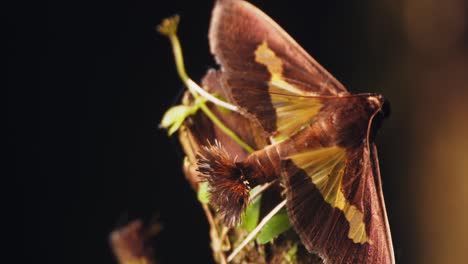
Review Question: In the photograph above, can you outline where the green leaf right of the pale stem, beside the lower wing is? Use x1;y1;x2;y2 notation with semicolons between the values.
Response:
257;208;291;244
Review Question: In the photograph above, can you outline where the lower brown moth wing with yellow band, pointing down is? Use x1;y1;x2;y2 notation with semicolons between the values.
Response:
284;145;395;264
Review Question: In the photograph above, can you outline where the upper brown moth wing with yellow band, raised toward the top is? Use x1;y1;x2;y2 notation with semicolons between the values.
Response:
209;0;348;134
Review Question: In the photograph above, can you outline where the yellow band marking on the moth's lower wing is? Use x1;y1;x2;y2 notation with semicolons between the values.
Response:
289;146;371;244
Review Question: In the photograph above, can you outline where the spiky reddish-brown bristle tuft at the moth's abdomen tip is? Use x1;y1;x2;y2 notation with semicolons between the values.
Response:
197;140;250;227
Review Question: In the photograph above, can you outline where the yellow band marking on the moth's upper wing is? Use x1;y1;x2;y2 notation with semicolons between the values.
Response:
255;41;322;137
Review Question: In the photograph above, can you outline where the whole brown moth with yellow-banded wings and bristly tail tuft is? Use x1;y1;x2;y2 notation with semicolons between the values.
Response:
197;0;395;263
